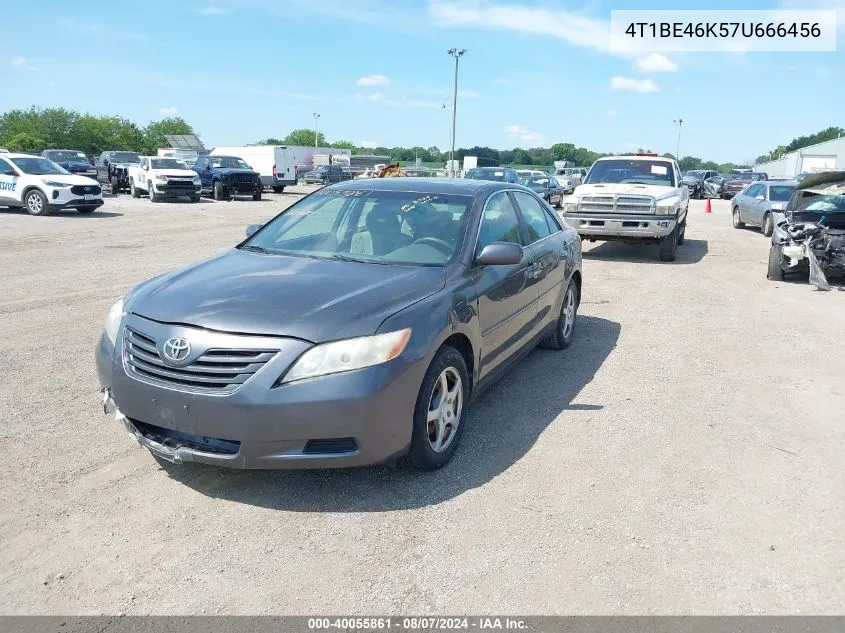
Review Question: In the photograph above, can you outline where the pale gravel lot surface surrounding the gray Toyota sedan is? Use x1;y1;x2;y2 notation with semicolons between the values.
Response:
0;189;845;615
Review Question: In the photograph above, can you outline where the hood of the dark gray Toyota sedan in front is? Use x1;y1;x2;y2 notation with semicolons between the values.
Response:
126;249;446;343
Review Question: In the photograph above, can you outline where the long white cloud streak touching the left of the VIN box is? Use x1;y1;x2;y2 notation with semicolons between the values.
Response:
436;0;613;53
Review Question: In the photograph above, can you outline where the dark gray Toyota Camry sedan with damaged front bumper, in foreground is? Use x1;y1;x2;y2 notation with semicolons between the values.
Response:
96;178;581;470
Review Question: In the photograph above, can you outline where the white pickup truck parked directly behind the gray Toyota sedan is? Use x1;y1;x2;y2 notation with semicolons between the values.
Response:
562;154;689;262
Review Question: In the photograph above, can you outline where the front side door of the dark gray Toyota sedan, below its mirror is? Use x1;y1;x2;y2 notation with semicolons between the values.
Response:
472;191;538;378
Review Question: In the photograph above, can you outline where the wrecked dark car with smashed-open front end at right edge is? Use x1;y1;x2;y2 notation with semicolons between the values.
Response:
766;171;845;290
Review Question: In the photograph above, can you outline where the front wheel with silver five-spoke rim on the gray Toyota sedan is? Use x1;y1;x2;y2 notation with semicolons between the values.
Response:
404;345;469;470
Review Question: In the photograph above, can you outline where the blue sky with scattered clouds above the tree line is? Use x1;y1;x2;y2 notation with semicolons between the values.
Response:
0;0;845;161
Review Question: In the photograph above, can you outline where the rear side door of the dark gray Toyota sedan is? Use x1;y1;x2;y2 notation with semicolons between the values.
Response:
511;191;567;326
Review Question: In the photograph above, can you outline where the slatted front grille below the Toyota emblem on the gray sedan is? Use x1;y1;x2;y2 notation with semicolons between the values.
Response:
123;327;277;393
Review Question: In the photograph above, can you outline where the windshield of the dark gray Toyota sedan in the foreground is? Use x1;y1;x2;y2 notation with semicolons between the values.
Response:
241;189;471;266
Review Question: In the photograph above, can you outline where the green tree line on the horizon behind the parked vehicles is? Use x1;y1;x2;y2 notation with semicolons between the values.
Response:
0;106;845;172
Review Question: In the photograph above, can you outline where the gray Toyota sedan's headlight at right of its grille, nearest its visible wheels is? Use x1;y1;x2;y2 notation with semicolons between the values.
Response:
280;328;411;384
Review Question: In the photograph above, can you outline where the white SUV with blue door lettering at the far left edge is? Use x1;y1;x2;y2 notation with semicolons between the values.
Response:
0;153;103;215
